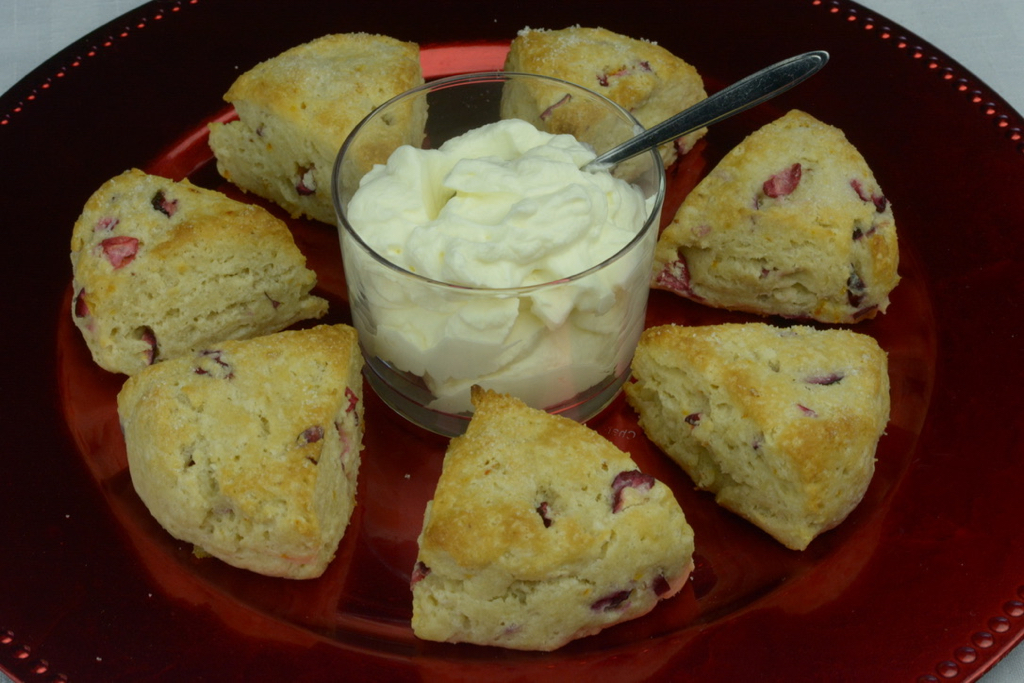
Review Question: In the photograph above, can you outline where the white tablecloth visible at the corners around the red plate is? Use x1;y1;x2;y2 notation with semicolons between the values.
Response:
0;0;1024;683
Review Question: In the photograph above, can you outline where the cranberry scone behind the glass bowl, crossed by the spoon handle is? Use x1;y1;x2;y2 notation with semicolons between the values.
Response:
505;27;708;165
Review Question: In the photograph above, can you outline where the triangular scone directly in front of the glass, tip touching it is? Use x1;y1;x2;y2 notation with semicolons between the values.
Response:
412;388;693;650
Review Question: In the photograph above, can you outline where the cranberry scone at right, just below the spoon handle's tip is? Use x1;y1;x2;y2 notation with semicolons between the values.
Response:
653;111;899;323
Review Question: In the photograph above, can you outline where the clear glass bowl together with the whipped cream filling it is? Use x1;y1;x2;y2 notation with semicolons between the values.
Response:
335;73;665;434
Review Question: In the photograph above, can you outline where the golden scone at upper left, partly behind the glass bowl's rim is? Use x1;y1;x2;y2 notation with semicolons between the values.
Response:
210;33;426;225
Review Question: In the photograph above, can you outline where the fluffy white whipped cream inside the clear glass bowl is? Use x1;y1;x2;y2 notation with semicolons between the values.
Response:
345;119;656;413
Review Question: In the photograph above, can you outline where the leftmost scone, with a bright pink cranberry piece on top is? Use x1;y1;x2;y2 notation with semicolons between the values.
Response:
71;169;328;375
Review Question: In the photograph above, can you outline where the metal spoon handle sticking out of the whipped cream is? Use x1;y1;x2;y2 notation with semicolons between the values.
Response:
586;50;828;169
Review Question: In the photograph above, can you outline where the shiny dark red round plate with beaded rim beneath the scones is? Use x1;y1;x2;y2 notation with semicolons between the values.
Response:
0;0;1024;681
